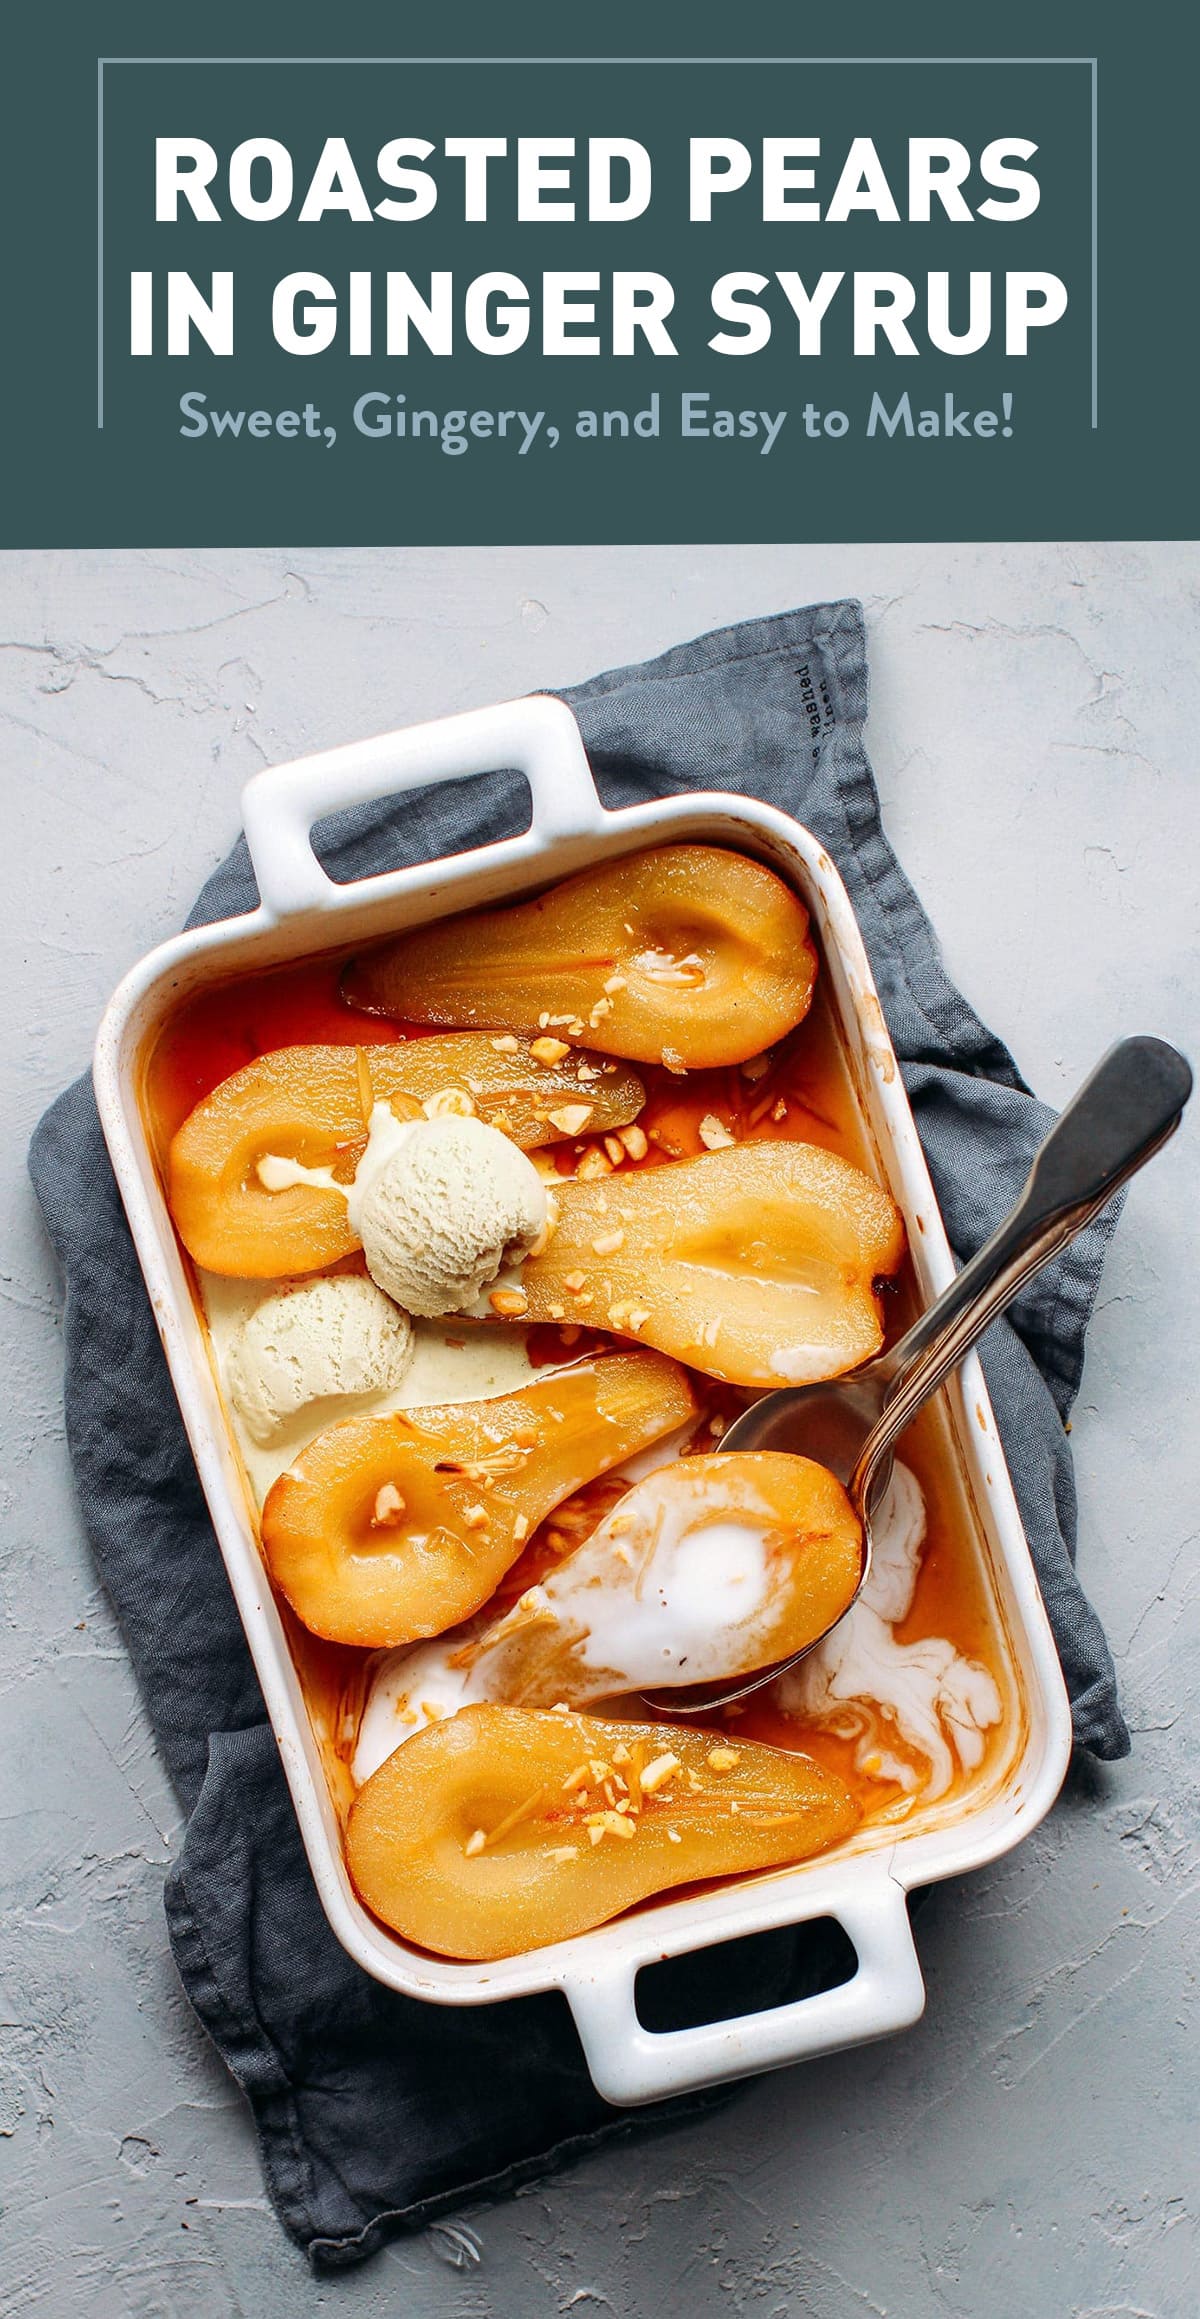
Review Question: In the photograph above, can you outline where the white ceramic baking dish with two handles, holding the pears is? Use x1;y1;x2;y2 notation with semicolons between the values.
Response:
95;698;1070;2103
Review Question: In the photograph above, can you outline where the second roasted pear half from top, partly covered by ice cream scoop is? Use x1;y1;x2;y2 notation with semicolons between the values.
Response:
167;1032;645;1280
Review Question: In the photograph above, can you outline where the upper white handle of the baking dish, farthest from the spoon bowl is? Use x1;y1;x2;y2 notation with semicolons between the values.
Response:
241;693;603;918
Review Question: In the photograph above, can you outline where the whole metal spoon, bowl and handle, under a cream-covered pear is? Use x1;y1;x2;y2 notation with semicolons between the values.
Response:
643;1039;1191;1716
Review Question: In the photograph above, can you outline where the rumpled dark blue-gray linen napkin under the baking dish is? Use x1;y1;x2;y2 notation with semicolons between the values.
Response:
30;603;1128;2270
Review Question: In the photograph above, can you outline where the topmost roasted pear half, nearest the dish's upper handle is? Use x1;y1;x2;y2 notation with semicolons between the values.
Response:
341;844;817;1071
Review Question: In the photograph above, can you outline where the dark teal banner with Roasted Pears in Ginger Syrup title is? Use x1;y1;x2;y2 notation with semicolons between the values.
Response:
2;7;1195;545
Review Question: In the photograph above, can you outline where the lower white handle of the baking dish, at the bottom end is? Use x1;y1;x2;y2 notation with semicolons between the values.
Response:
566;1874;926;2103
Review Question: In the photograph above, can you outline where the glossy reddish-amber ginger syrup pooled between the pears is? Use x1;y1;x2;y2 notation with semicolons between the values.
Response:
144;932;1017;1823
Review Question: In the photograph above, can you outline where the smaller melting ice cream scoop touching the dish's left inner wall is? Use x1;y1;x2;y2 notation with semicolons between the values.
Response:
225;1273;413;1445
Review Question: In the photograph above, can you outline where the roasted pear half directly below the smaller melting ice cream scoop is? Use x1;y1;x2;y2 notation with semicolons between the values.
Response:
262;1352;696;1646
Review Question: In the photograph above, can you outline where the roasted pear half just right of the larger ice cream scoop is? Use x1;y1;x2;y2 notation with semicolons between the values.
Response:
505;1143;905;1387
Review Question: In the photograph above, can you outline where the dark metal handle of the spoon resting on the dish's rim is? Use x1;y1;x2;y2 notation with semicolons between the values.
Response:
850;1039;1191;1503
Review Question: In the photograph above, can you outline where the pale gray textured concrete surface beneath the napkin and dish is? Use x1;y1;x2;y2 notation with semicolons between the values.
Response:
0;545;1200;2319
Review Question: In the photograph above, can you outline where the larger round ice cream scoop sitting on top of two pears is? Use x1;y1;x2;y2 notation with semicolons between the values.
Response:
346;1104;545;1320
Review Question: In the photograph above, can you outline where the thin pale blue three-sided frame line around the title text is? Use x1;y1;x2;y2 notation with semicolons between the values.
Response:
95;56;1100;431
